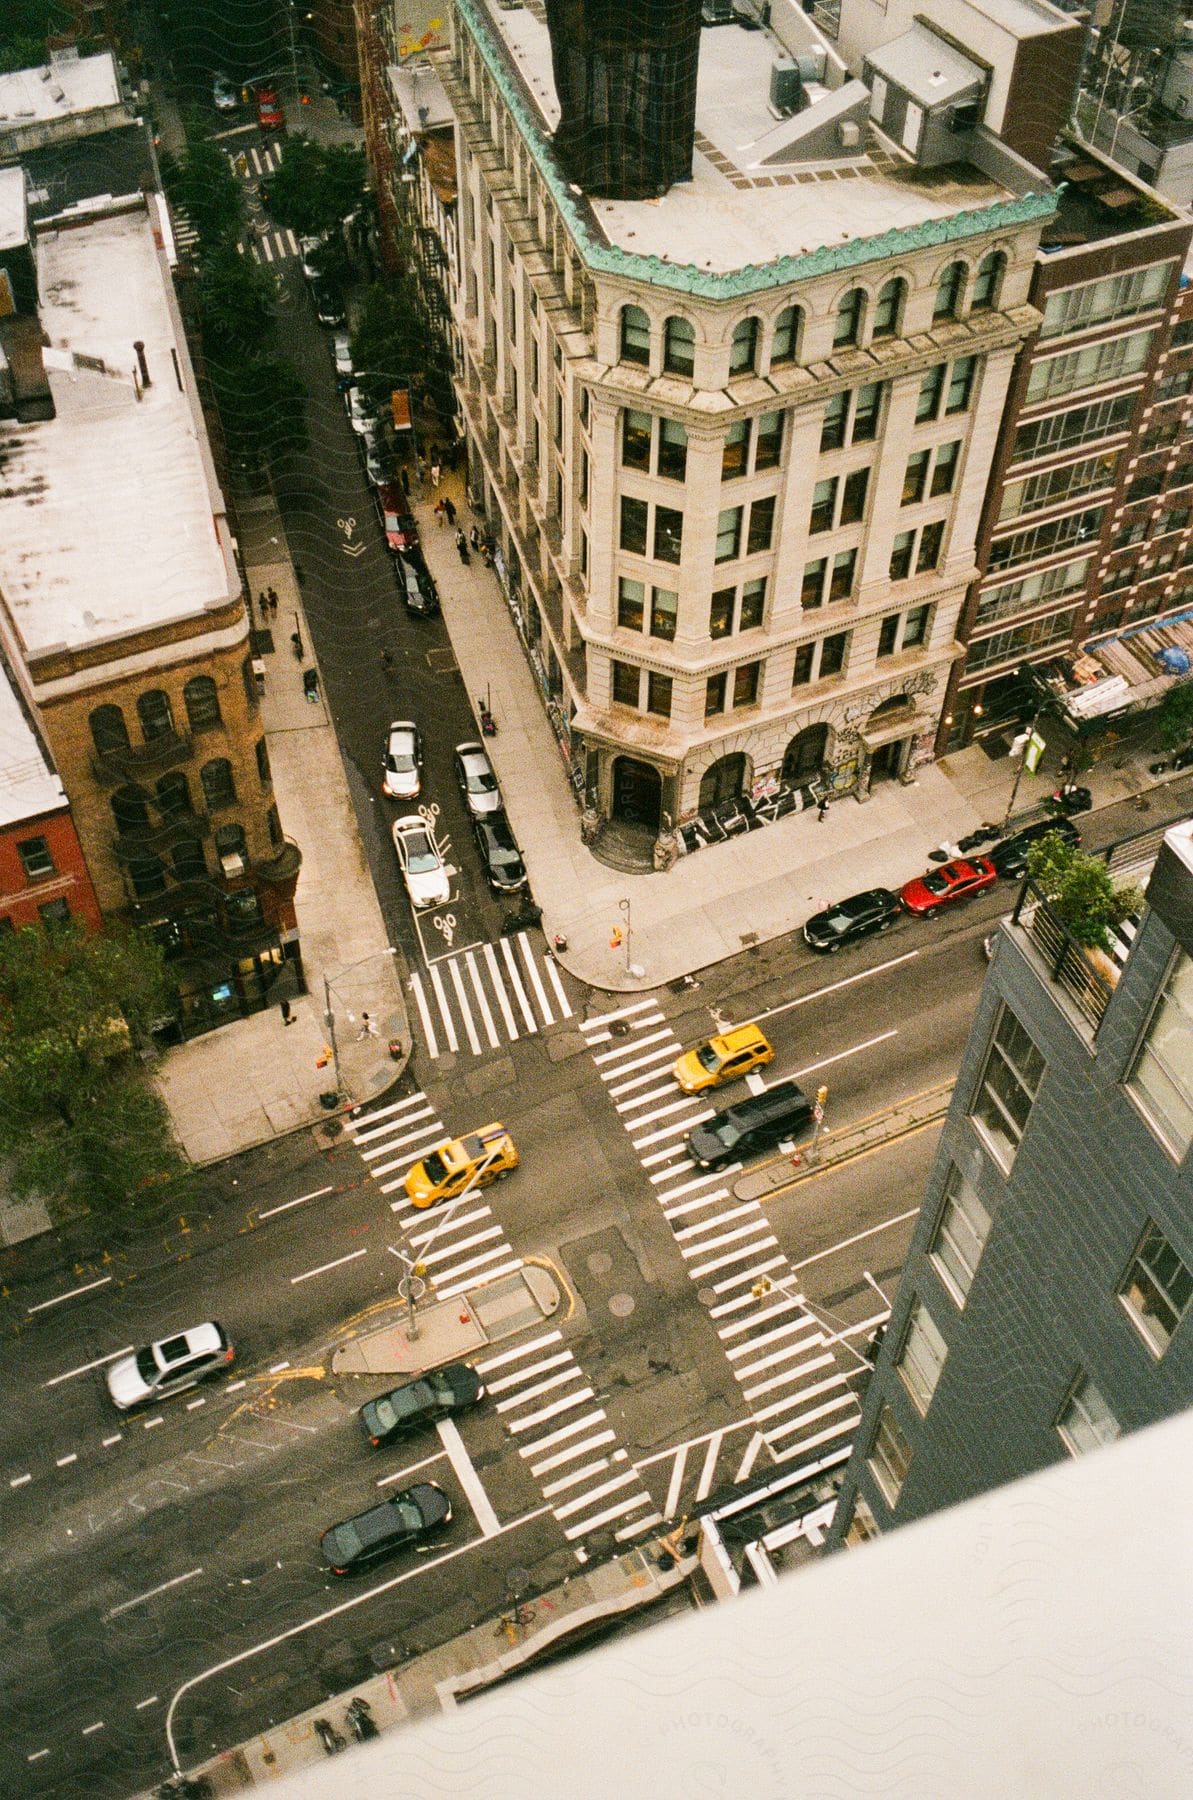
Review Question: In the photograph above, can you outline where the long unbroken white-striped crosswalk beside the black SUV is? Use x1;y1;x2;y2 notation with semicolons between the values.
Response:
579;1001;860;1462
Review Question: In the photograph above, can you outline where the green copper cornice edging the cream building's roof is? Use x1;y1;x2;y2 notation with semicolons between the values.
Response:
453;0;1056;301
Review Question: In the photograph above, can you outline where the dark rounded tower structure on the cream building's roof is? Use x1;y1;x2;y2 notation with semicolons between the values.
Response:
547;0;700;200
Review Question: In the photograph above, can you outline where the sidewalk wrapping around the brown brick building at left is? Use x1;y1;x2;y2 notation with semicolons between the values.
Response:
157;499;410;1163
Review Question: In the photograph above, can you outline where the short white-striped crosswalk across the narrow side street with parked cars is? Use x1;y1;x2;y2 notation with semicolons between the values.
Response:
410;931;572;1058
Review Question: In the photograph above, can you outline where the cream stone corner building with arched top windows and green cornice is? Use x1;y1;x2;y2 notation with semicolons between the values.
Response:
437;0;1054;833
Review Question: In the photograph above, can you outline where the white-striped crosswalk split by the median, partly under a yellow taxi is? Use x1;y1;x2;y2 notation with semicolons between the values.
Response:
347;1093;662;1561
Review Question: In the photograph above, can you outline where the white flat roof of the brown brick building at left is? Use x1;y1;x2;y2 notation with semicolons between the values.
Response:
0;207;234;655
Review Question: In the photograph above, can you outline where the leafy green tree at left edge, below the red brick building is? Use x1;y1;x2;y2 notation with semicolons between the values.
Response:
0;925;187;1213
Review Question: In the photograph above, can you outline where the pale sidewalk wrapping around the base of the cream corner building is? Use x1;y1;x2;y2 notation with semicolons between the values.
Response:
414;472;1193;992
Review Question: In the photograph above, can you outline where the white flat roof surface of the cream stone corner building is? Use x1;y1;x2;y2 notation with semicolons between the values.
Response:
488;0;1013;274
